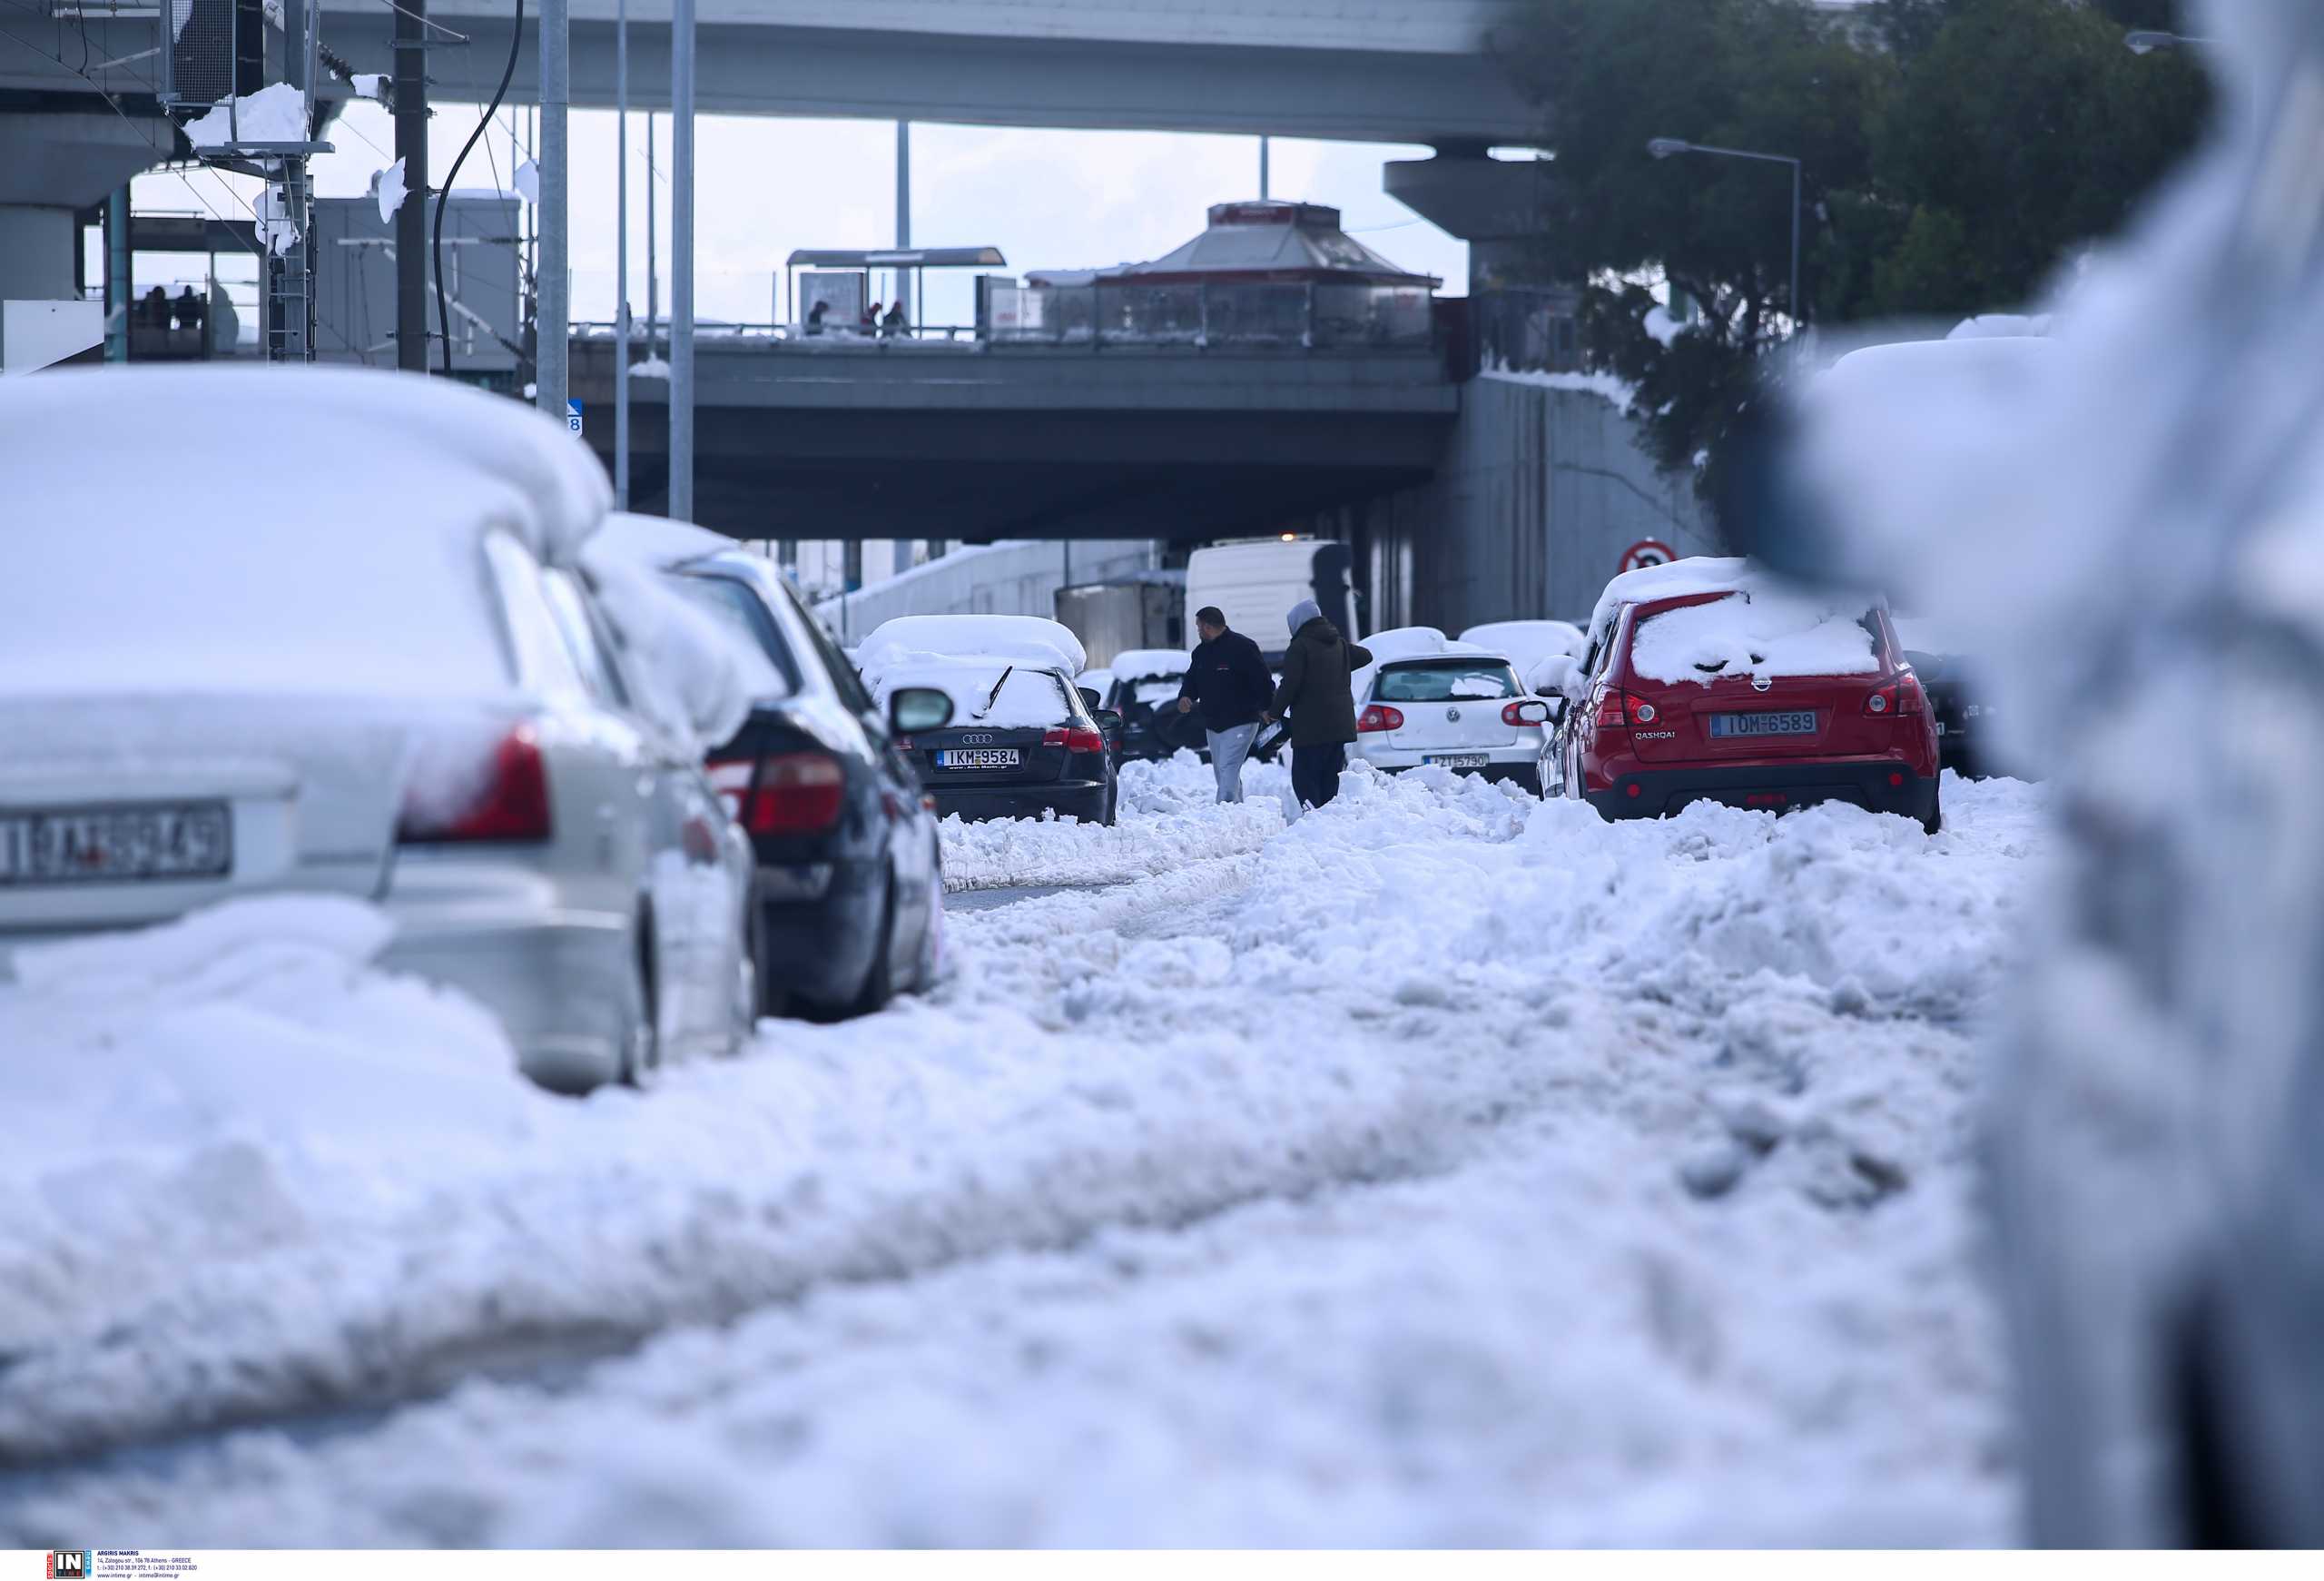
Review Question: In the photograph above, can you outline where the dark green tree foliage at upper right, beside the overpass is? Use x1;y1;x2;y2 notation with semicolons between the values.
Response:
1499;0;2211;480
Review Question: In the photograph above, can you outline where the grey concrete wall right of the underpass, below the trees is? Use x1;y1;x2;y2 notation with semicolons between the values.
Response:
1348;374;1719;630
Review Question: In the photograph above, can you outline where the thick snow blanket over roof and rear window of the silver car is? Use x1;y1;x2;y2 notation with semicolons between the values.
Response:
0;368;611;697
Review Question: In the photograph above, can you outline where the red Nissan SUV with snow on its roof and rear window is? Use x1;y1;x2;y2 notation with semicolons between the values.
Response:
1557;574;1943;835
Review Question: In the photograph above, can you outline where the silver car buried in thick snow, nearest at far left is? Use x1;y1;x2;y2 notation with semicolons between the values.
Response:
0;368;753;1091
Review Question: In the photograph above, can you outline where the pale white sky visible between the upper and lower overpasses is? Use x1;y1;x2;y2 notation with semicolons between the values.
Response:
127;103;1469;323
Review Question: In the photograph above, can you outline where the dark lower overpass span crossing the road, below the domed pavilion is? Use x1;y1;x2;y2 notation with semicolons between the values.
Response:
572;335;1460;542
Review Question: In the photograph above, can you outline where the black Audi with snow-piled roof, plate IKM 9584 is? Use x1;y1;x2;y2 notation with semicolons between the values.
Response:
860;614;1120;823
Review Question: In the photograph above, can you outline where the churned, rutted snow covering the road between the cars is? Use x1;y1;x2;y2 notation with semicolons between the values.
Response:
0;763;2043;1546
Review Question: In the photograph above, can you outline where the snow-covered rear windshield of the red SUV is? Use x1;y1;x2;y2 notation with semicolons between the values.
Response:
1630;590;1880;684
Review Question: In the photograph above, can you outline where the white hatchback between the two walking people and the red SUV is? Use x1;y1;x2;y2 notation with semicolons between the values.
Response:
1348;626;1551;795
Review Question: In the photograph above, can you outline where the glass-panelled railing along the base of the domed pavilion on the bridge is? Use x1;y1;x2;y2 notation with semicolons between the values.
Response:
985;282;1436;349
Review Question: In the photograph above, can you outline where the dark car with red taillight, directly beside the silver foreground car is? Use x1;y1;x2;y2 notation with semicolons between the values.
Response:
608;514;953;1016
